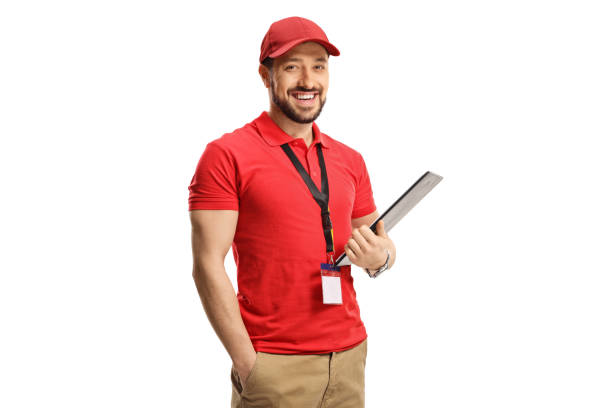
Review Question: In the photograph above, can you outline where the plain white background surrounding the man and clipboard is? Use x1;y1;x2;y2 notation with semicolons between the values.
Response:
0;0;612;408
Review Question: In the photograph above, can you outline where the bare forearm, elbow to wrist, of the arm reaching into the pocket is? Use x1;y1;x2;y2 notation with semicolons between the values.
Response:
193;261;255;367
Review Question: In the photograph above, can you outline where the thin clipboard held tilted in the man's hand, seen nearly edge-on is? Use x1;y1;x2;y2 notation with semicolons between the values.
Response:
334;171;442;266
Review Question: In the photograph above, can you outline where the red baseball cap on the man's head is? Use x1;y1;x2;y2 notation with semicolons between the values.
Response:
259;17;340;63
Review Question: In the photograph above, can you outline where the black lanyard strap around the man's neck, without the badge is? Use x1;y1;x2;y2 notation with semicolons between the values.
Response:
281;143;334;263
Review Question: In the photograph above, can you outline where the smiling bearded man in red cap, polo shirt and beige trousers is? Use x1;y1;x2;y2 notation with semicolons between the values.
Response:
189;17;395;408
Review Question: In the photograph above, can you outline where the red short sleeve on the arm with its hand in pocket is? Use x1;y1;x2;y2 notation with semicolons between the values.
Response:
189;142;239;211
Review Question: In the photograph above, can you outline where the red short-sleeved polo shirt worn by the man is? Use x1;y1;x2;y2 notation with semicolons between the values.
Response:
189;111;376;354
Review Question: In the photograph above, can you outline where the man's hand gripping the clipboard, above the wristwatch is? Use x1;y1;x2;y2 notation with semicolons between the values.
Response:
344;220;394;269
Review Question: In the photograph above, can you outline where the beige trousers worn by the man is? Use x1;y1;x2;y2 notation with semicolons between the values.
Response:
231;338;368;408
